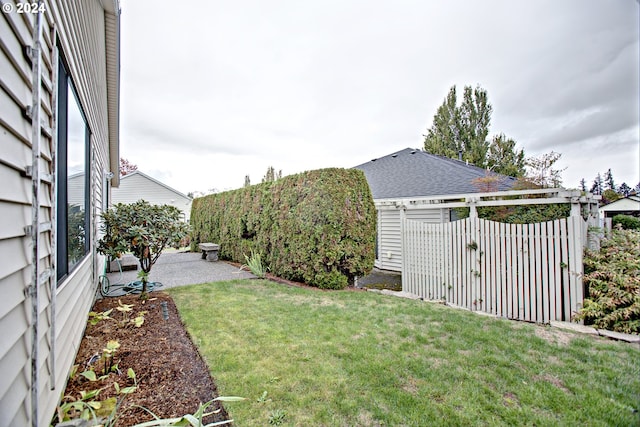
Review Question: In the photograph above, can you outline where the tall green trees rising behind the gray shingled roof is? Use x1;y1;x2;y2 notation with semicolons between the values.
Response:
424;86;525;177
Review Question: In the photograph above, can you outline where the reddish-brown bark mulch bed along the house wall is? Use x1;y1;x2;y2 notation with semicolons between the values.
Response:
56;292;228;426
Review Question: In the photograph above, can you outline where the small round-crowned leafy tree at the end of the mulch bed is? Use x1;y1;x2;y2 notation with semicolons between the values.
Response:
98;200;188;299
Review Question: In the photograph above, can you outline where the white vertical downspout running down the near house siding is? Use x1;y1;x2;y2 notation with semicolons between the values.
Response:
29;6;42;427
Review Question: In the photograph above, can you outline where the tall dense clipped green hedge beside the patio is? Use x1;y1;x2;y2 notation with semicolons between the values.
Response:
191;169;376;289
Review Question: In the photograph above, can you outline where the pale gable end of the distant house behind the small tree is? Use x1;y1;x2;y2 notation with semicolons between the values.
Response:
111;172;191;221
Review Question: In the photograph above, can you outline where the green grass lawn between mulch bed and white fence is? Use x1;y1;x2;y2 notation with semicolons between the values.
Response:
168;280;640;427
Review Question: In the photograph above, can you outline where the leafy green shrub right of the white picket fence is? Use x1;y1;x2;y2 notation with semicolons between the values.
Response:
575;230;640;334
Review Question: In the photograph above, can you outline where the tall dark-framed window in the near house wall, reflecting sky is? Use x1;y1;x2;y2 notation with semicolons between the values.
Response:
56;59;91;281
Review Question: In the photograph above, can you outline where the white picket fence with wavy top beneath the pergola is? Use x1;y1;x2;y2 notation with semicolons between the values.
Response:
402;216;586;323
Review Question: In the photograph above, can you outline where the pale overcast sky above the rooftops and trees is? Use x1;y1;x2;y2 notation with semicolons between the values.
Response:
120;0;640;193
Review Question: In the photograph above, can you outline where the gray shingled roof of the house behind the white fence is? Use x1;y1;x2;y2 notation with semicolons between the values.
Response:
354;148;516;199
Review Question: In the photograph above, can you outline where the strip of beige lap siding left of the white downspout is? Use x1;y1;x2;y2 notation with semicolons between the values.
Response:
0;1;45;425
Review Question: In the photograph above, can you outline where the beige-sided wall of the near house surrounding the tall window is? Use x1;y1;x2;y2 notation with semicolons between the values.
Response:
0;0;119;426
